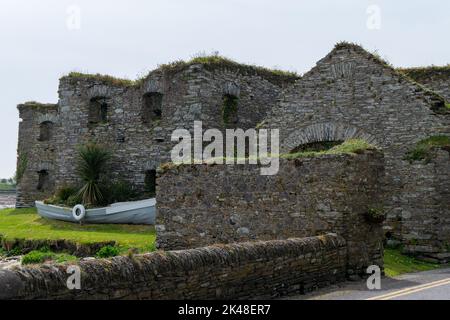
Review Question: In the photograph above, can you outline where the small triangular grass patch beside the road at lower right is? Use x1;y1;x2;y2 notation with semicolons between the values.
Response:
384;249;441;277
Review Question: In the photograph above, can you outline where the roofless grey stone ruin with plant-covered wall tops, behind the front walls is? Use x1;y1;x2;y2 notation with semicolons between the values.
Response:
16;43;450;260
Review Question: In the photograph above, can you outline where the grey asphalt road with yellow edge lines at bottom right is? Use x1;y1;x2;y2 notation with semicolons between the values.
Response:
288;268;450;300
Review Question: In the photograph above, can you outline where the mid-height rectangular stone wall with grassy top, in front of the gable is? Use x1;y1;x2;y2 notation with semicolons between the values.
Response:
156;151;384;274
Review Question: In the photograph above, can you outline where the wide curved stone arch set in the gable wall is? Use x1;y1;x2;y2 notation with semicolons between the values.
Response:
281;122;378;152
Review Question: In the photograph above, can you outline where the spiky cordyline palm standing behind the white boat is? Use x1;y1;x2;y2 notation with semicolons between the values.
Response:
77;143;110;206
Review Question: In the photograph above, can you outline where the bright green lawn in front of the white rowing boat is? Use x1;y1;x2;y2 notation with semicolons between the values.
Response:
0;208;156;252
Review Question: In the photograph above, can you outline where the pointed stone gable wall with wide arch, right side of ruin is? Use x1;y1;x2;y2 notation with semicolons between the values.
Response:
266;44;450;258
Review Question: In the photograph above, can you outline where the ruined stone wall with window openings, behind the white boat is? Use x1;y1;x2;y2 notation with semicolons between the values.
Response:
18;64;292;206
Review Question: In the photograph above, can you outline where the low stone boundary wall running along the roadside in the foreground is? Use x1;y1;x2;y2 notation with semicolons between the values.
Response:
0;234;347;299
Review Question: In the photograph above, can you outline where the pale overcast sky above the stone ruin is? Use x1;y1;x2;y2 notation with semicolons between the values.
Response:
0;0;450;177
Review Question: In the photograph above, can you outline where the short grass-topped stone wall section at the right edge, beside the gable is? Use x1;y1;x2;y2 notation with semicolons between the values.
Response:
399;149;450;262
